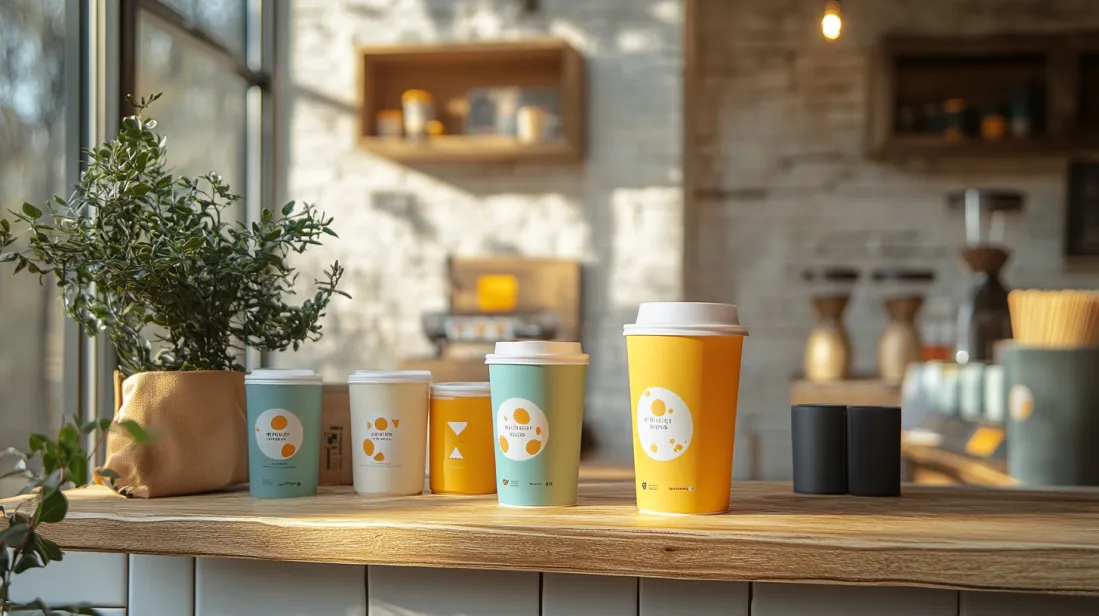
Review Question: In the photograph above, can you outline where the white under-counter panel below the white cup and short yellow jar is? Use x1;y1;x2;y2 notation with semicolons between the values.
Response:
367;567;539;616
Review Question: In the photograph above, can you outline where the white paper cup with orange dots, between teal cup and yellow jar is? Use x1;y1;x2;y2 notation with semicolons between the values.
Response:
347;370;431;496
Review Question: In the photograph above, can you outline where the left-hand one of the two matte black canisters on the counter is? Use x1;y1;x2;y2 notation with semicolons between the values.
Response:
790;404;847;494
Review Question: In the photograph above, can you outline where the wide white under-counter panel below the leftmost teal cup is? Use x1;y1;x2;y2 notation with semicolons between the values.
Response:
195;558;366;616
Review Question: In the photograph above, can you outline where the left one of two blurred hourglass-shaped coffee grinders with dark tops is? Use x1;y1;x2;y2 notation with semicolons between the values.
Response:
801;267;858;382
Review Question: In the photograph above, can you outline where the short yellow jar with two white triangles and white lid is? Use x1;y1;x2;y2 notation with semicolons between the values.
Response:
429;382;496;494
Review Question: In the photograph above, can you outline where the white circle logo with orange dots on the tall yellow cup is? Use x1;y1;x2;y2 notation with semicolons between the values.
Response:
637;388;695;462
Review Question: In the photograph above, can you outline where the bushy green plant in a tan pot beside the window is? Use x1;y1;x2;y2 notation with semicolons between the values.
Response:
0;94;345;497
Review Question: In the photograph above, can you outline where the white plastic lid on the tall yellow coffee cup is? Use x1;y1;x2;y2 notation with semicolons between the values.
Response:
623;302;748;336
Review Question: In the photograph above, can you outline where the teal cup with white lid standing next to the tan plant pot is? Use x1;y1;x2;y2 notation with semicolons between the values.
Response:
244;370;323;499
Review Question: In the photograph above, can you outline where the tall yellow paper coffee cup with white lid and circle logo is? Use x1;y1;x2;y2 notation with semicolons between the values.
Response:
625;302;748;514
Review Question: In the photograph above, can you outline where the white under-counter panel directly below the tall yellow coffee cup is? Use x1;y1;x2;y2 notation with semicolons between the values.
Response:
637;578;750;616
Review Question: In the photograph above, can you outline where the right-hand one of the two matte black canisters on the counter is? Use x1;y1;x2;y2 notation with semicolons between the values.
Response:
847;406;900;496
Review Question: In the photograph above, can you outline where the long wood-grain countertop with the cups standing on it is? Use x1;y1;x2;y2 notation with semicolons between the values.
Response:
3;470;1099;595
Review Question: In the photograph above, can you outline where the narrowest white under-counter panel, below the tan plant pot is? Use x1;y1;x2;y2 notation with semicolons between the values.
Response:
126;555;195;616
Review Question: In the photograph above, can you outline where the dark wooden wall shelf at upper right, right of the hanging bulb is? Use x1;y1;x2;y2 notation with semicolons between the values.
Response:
867;32;1099;159
